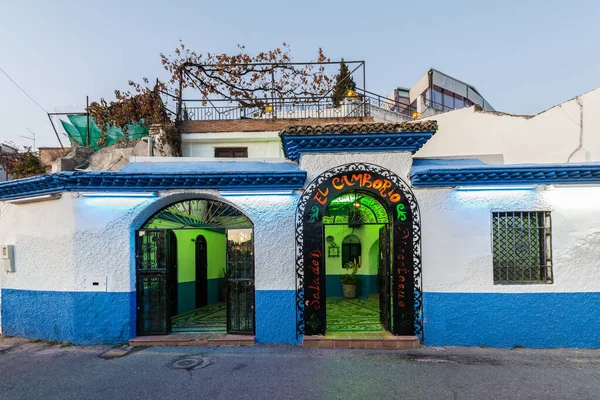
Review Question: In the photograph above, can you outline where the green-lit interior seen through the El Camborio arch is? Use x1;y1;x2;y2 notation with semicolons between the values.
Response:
323;191;389;333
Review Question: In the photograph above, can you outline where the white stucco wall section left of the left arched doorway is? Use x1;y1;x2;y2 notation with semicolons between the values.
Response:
0;193;155;292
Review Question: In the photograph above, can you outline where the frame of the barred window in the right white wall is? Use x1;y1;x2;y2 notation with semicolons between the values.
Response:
489;209;555;285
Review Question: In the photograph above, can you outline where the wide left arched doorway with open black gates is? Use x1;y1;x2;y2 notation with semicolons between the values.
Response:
136;199;255;335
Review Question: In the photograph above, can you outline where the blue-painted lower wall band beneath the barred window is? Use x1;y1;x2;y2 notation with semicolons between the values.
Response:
423;292;600;348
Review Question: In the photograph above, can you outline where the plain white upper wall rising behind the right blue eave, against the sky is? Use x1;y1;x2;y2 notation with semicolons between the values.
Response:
415;89;600;164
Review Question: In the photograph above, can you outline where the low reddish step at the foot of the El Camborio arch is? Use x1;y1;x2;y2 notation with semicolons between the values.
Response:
302;332;421;349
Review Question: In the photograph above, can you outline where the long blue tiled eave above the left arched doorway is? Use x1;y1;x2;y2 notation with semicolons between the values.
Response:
0;162;306;200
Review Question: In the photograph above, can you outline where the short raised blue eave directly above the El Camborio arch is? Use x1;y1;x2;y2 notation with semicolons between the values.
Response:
281;131;435;161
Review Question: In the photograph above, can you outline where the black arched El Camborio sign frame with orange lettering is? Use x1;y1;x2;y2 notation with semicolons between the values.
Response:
299;164;421;335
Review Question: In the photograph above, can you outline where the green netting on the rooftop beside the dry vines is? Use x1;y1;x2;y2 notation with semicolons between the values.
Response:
60;115;149;150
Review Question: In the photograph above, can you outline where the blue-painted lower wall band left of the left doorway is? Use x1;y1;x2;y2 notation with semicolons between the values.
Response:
2;289;136;344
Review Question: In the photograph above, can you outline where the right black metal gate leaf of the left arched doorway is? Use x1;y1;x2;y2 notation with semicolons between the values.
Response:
227;229;255;335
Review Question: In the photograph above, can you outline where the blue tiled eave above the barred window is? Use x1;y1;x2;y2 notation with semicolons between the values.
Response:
410;163;600;187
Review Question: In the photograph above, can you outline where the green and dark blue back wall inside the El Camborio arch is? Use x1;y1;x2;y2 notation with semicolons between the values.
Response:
325;224;383;297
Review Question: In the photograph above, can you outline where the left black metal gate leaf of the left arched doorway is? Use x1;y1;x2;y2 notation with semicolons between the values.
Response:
136;230;174;335
